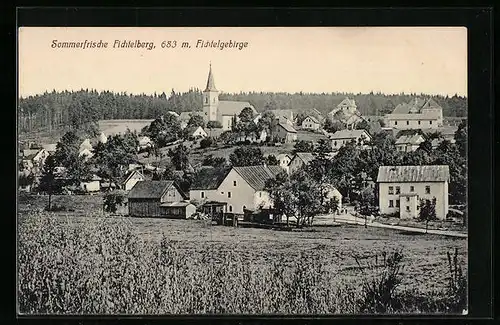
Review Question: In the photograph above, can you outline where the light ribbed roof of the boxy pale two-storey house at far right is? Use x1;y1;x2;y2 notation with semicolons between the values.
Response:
377;165;450;183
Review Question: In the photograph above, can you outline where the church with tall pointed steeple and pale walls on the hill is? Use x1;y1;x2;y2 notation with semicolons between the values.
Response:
203;64;258;131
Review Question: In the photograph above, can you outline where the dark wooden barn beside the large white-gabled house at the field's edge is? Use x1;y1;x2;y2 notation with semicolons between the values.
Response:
128;180;188;217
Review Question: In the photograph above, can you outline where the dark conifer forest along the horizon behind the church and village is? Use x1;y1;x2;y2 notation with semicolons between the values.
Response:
19;89;467;131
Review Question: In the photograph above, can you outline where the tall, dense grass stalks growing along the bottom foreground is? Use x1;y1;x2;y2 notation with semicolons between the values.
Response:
18;214;463;314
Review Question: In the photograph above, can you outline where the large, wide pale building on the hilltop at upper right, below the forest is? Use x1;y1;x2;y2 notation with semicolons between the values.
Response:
385;98;443;130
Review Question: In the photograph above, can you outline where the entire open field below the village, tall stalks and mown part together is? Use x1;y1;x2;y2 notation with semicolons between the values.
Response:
19;196;466;314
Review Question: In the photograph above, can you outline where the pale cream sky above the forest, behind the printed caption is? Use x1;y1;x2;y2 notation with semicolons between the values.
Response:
18;27;467;97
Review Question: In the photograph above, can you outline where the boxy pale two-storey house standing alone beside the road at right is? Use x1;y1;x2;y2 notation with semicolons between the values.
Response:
377;165;450;220
